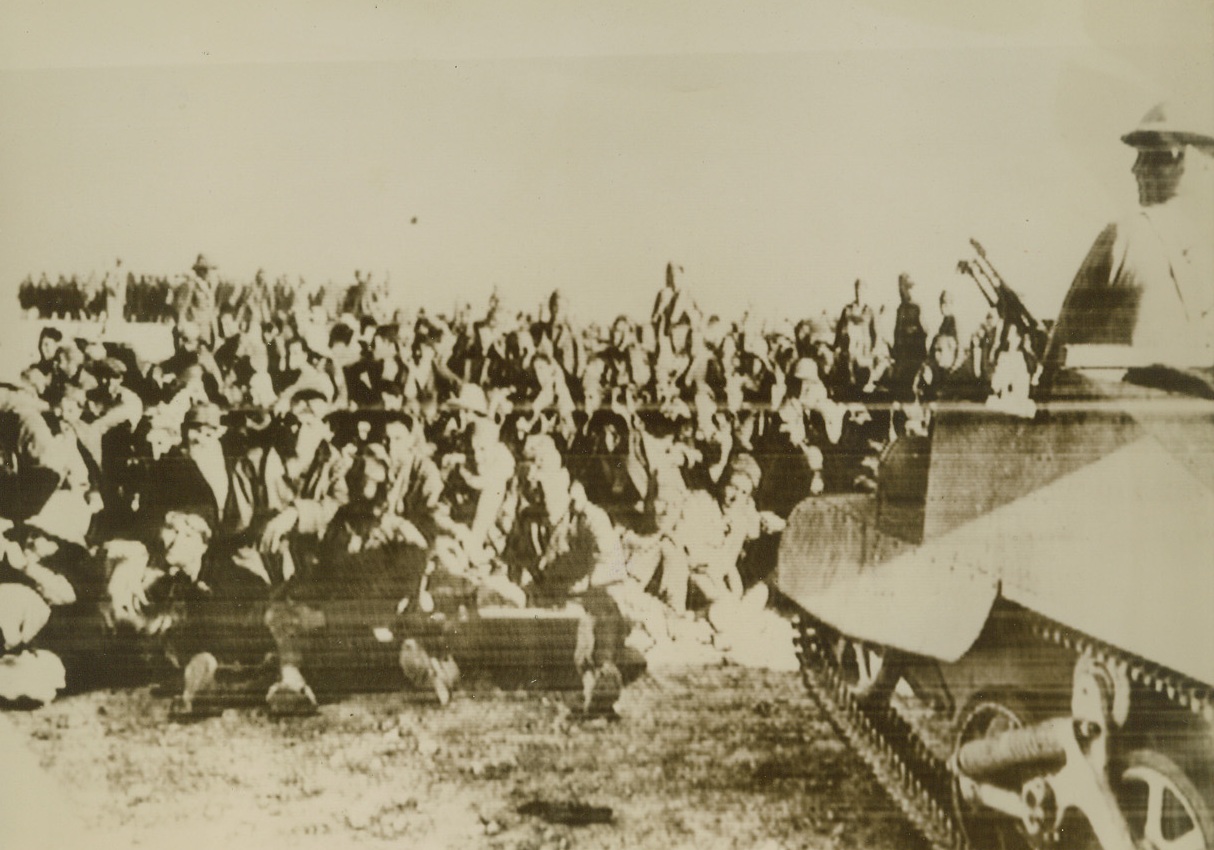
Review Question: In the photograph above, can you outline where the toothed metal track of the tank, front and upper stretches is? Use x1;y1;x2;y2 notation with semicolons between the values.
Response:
794;611;1214;850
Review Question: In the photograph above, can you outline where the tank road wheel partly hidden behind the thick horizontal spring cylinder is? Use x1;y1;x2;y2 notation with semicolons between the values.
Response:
953;697;1038;850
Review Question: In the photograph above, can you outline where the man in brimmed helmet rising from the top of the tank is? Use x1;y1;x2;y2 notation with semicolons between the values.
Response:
1045;99;1214;369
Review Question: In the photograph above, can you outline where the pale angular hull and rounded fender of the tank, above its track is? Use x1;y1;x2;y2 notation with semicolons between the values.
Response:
776;402;1214;684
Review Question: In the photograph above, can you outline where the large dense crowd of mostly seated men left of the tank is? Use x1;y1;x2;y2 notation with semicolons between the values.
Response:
0;256;1036;713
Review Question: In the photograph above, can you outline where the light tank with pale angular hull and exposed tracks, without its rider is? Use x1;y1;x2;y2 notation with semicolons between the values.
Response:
775;244;1214;850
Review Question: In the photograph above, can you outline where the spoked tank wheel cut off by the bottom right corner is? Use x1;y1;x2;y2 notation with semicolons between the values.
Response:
1118;749;1214;850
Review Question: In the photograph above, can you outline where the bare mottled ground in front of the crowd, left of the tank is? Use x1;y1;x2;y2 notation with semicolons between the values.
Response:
8;662;923;850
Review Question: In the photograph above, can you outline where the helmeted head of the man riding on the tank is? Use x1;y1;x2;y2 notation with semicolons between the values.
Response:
1122;103;1214;206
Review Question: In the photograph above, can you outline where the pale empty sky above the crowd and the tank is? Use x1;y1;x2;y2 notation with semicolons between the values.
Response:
0;0;1214;327
